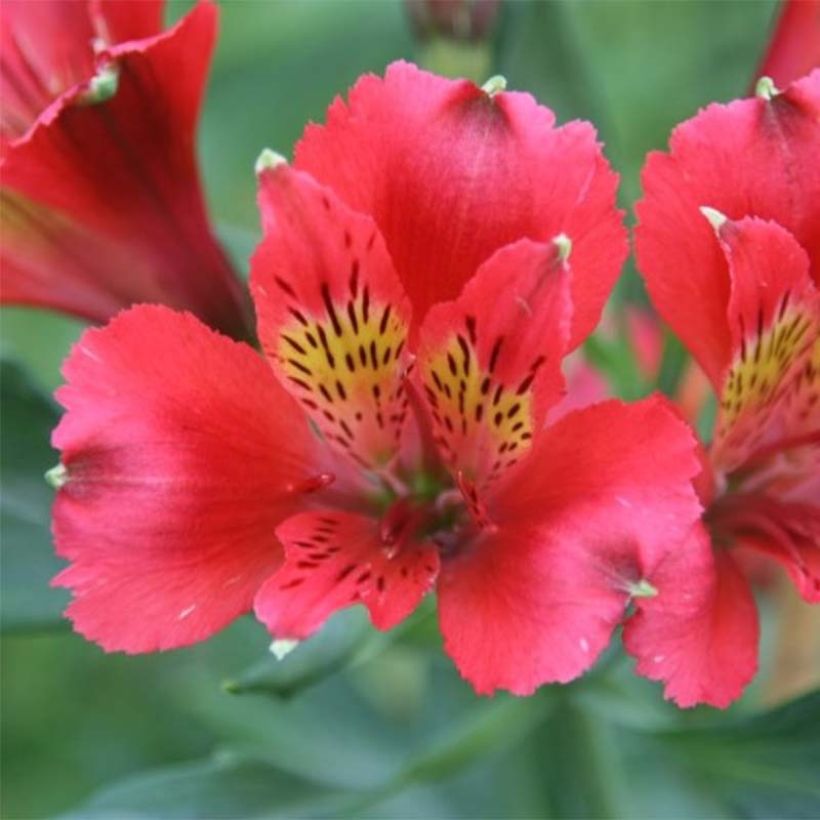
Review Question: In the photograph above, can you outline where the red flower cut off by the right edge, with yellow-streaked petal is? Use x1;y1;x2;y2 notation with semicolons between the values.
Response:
626;71;820;704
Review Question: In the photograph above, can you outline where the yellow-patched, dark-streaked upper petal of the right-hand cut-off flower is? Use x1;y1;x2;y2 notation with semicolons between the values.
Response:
712;218;820;471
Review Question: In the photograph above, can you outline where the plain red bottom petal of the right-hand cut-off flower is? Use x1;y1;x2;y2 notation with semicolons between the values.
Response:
624;527;759;708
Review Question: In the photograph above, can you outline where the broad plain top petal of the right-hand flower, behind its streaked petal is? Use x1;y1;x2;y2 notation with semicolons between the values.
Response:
636;71;820;387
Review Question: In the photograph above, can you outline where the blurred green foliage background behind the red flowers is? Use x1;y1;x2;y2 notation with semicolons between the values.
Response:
2;0;820;818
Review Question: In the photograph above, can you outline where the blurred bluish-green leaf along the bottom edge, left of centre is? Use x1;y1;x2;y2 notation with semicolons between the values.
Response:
69;752;346;820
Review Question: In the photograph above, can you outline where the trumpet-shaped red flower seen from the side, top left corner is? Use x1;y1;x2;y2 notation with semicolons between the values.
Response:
0;0;248;338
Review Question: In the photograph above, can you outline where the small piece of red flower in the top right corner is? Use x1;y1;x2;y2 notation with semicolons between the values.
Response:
757;0;820;88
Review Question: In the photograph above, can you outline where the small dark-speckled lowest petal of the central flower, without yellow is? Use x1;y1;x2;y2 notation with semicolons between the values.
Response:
255;510;439;640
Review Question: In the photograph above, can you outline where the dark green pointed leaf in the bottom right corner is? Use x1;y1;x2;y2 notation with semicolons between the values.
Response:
655;690;820;818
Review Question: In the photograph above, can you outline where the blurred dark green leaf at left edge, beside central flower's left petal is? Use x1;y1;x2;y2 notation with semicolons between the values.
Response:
0;358;67;632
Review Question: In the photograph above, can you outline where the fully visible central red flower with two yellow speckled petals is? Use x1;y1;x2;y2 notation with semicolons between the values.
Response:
54;64;700;693
